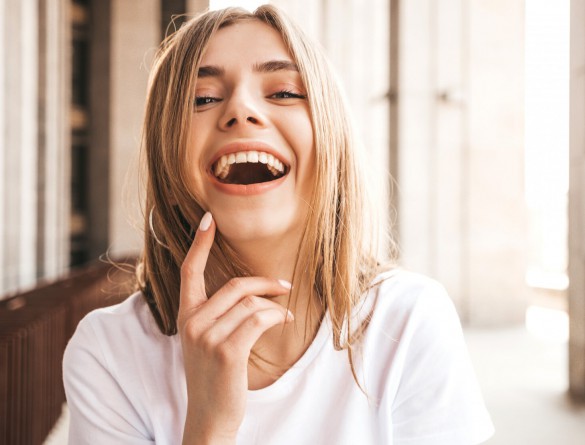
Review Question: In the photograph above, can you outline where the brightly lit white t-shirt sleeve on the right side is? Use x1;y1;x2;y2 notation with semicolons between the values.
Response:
383;282;493;445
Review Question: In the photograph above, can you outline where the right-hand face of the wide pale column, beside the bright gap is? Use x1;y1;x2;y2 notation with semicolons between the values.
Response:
468;0;529;324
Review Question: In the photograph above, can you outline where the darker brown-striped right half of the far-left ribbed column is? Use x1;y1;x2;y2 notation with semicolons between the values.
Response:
37;0;71;279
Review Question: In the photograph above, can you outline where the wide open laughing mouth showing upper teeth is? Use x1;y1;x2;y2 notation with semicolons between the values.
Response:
211;151;289;185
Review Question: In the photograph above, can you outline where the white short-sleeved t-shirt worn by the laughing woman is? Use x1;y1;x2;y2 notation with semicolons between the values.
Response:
64;271;493;445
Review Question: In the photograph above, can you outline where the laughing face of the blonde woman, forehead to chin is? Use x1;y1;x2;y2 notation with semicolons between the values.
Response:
187;20;314;245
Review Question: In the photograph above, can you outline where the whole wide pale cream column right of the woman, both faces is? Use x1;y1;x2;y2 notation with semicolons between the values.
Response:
398;0;528;325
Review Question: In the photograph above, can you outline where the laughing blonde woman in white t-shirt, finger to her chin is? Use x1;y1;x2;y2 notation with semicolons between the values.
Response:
64;6;492;445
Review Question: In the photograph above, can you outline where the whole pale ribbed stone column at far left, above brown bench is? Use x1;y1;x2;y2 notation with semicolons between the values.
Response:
0;0;70;295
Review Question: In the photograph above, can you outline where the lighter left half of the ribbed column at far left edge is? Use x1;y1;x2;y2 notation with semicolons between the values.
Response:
0;0;38;292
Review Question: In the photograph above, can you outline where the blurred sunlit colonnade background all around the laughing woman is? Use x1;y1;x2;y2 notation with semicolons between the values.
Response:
0;0;585;445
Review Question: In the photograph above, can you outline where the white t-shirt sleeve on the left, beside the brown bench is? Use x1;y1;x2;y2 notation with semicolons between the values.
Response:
63;314;154;445
